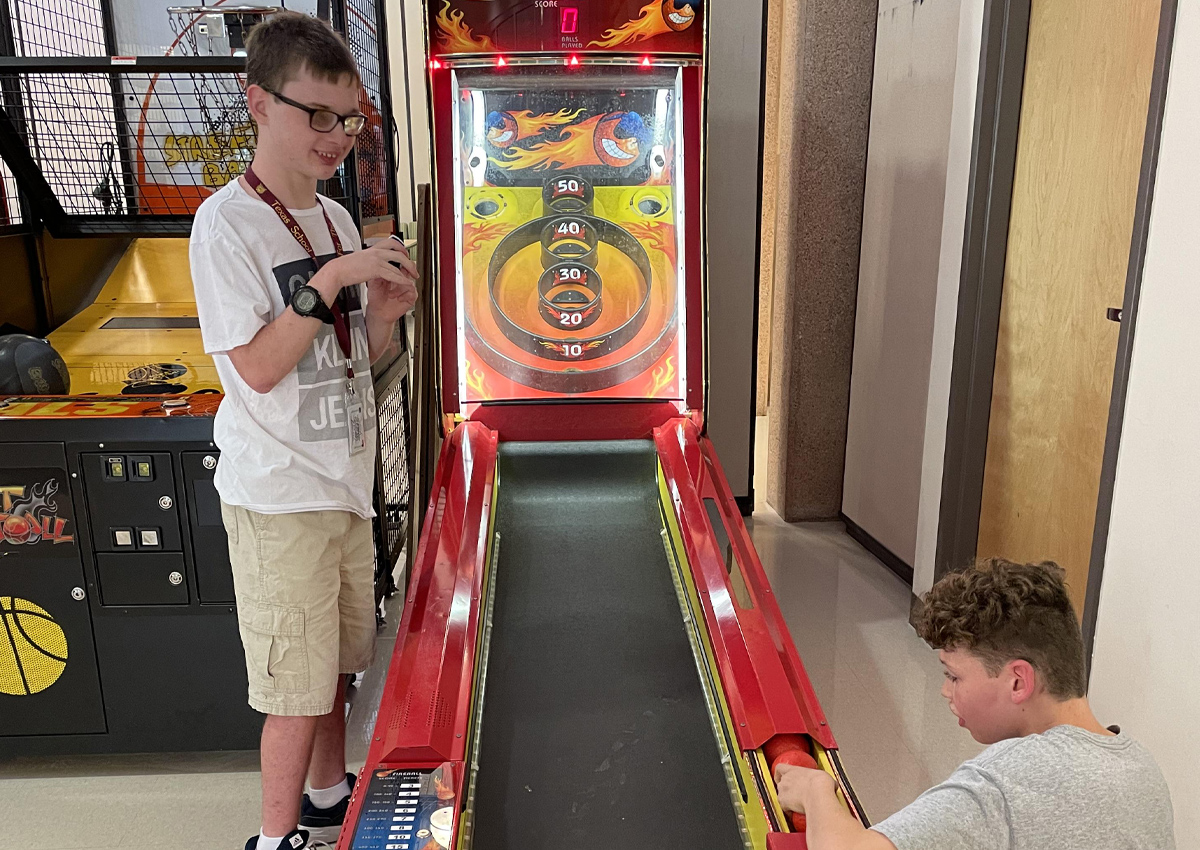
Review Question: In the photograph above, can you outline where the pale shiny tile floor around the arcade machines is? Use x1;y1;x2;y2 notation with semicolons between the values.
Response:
0;421;980;850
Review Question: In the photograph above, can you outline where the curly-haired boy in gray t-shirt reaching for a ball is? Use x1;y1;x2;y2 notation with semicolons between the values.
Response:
775;558;1175;850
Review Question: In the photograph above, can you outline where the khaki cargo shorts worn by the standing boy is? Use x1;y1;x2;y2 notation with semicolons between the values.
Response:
221;502;376;717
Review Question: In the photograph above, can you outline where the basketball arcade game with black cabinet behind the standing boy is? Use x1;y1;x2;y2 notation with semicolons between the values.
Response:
0;0;409;754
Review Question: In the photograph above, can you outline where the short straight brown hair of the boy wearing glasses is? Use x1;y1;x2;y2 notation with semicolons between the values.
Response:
246;12;359;91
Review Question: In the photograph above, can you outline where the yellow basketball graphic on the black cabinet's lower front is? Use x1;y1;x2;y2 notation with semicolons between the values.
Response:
0;597;67;696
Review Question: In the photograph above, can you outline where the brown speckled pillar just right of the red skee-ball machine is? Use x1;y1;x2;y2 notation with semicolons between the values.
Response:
760;0;878;521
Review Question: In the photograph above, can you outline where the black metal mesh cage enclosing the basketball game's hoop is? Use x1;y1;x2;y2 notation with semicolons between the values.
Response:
0;0;392;235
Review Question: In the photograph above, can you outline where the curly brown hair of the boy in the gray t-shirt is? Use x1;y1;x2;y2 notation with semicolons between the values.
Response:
917;558;1086;699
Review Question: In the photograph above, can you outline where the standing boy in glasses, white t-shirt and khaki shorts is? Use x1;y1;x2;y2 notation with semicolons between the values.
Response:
191;12;416;850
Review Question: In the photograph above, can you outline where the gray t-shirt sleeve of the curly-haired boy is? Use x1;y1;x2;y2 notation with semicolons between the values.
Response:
871;764;1009;850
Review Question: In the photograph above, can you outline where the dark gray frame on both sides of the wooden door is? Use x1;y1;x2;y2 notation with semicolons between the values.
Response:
934;0;1178;672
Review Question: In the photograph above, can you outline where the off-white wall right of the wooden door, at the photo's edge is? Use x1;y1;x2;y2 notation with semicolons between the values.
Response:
1091;2;1200;848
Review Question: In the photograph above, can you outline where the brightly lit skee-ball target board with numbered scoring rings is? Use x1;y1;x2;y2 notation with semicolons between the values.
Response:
451;66;689;405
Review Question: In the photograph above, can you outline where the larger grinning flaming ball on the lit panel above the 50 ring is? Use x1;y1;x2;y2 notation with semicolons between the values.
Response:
490;112;648;170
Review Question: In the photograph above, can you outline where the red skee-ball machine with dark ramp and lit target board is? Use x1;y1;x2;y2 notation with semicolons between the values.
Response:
338;0;865;850
